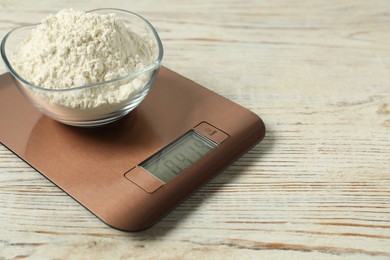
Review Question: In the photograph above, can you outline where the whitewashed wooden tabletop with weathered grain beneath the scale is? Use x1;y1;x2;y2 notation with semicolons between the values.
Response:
0;0;390;259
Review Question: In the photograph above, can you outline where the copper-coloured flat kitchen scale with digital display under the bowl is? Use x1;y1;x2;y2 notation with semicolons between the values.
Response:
0;67;265;231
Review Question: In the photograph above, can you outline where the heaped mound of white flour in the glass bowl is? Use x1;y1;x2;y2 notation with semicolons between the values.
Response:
12;9;156;114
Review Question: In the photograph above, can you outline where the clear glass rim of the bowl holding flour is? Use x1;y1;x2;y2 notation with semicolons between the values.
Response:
0;8;164;92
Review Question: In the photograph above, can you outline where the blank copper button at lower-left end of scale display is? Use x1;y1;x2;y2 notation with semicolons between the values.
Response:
125;166;164;193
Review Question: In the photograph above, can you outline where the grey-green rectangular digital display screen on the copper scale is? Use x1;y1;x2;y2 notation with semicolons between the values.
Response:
140;130;217;183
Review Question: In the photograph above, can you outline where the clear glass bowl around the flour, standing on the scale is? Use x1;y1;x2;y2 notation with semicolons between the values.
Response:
1;9;163;127
